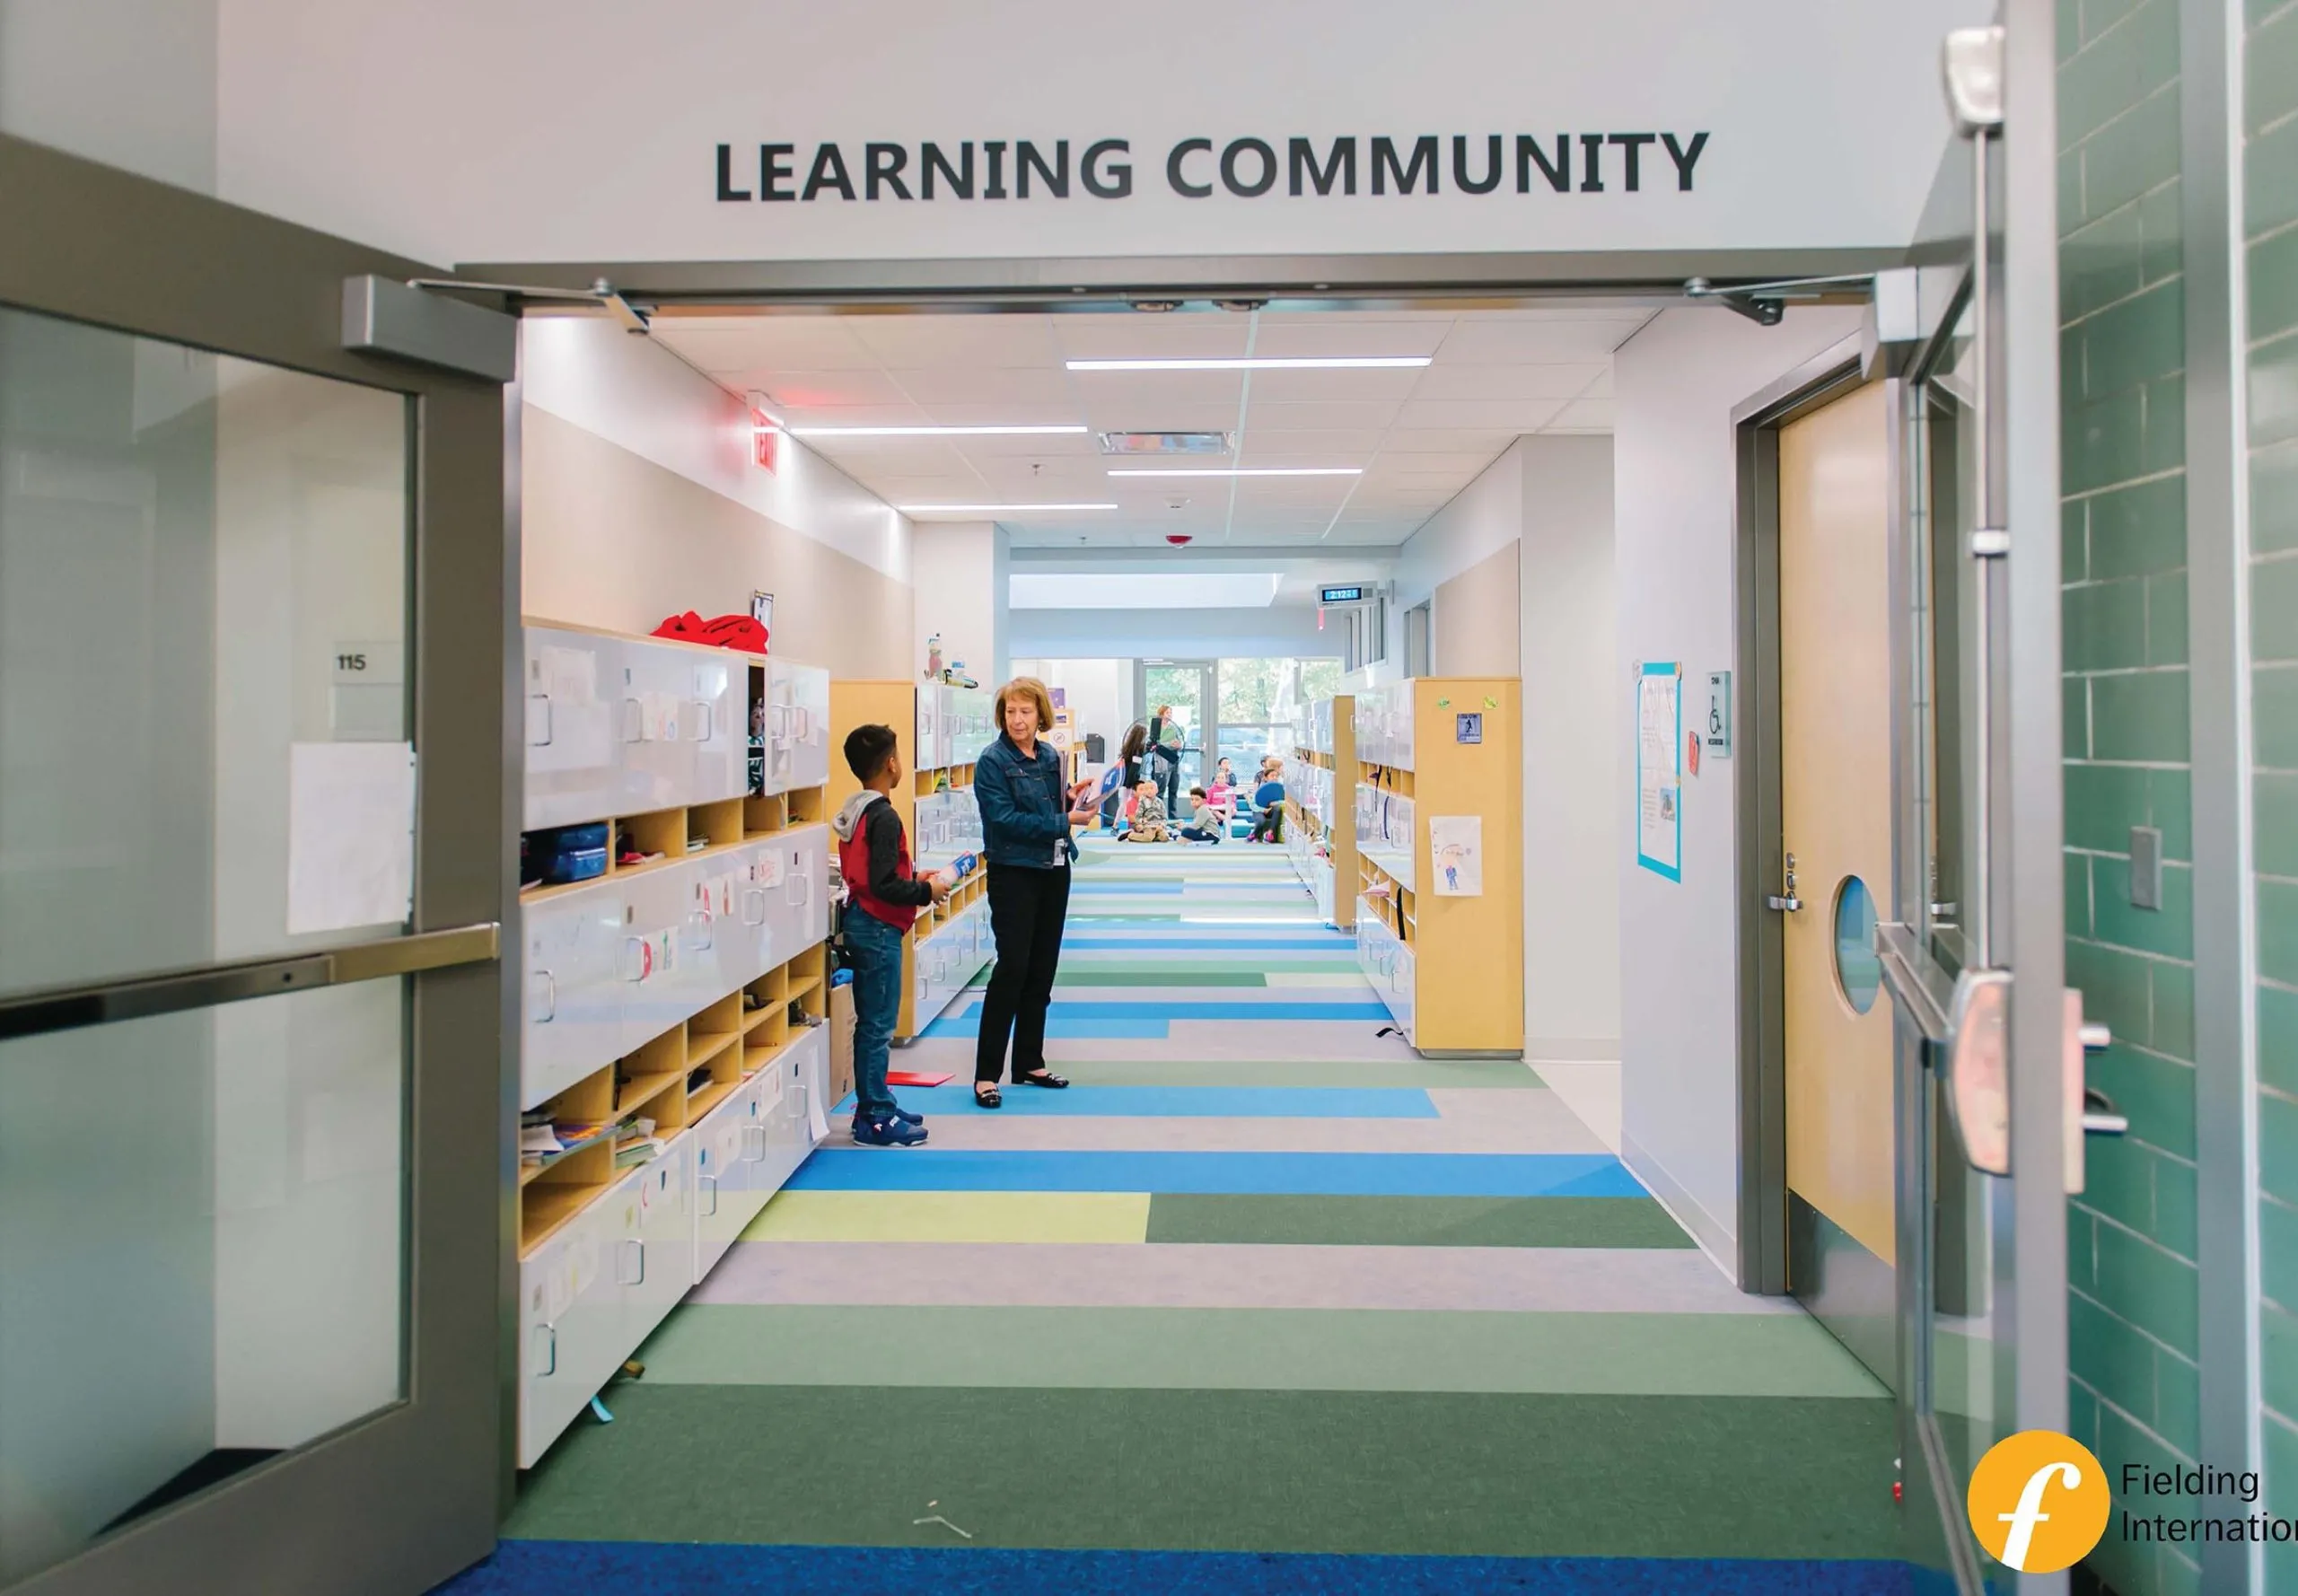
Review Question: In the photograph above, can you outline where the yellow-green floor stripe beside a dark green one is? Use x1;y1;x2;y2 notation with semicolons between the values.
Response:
742;1185;1149;1242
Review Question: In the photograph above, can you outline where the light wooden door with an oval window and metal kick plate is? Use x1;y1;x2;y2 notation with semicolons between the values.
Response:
1778;383;1896;1263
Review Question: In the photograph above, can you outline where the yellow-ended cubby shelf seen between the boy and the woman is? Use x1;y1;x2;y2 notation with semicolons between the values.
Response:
829;682;997;1042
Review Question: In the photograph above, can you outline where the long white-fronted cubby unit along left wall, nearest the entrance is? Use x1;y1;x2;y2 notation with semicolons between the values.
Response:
514;622;829;1468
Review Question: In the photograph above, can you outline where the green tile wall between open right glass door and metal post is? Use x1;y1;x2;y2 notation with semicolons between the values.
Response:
2059;0;2197;1596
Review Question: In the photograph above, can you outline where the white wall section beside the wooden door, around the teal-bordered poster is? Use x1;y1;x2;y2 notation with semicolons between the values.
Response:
1606;308;1859;1260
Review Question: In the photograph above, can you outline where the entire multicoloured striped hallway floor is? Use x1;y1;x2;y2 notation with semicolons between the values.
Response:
451;843;1903;1596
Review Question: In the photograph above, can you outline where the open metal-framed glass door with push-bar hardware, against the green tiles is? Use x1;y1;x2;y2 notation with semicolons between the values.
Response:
1875;18;2117;1593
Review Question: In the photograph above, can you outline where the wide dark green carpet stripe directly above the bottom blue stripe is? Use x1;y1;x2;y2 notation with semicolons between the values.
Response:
505;1387;1899;1557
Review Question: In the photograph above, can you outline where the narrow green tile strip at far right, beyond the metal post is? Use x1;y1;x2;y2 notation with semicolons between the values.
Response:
2241;0;2298;1593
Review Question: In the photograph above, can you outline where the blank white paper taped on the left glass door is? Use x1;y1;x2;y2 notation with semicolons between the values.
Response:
287;741;416;937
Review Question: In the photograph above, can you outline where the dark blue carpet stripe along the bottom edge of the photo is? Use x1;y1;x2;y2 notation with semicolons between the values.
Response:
438;1541;1909;1596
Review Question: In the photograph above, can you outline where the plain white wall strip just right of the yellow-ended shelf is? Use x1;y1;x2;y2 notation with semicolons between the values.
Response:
1514;439;1627;1061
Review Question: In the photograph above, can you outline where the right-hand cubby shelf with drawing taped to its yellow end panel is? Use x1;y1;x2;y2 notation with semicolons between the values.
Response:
1335;678;1523;1057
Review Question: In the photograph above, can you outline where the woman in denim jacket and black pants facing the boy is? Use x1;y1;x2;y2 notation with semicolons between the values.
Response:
974;675;1094;1109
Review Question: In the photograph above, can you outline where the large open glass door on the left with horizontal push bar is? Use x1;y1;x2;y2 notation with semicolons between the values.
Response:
0;137;513;1596
